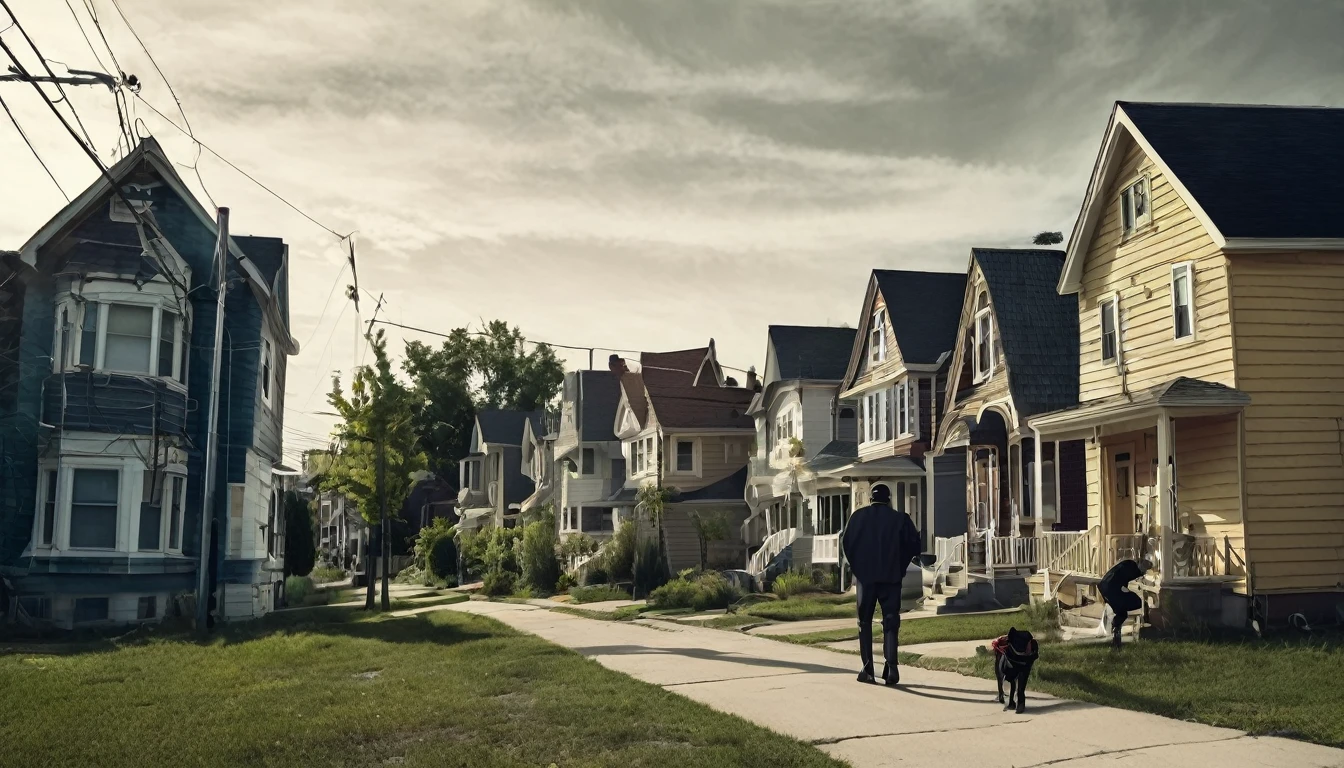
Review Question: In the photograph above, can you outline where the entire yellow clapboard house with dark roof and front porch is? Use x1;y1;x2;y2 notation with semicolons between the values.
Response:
1028;102;1344;624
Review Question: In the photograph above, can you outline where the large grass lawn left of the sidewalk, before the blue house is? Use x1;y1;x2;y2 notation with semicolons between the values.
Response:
0;607;839;768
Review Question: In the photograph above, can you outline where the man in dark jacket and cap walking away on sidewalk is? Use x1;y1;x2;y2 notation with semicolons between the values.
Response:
841;484;922;686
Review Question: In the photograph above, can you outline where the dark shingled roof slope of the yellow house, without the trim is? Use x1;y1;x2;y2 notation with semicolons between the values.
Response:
1120;102;1344;238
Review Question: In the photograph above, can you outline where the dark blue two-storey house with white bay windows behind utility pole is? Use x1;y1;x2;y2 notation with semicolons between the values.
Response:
0;139;298;628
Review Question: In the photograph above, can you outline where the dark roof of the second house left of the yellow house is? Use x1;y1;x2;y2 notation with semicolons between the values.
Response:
872;269;966;364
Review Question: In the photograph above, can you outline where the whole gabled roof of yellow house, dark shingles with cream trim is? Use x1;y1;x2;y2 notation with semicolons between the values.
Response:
1059;101;1344;293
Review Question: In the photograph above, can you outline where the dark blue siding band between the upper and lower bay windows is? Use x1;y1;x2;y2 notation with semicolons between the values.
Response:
42;373;187;436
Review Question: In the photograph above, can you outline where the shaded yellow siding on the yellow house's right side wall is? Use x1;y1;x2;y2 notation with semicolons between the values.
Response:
1230;253;1344;590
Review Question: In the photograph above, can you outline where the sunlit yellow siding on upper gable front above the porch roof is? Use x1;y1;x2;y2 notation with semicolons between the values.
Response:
1078;141;1235;402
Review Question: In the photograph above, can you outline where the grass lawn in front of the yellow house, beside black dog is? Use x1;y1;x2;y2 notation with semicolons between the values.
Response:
900;632;1344;746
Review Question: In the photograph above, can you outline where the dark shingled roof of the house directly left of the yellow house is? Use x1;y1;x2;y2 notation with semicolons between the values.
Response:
970;247;1078;417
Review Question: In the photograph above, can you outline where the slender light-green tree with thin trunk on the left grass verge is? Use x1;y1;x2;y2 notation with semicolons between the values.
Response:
320;331;425;611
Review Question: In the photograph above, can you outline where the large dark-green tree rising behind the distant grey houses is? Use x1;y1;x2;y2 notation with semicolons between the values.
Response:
403;320;564;477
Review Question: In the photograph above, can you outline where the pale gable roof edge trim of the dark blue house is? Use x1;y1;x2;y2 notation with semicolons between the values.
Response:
20;137;298;355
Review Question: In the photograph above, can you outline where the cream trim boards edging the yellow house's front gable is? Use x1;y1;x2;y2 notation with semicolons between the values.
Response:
1058;102;1231;293
